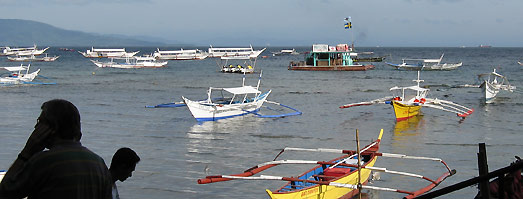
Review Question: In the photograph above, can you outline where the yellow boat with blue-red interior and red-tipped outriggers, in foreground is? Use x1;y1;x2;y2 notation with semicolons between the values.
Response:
198;129;456;199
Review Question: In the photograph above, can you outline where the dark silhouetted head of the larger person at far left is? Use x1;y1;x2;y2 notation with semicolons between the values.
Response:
38;99;82;141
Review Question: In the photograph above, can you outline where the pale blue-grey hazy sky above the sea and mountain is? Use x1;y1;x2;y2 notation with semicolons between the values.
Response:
0;0;523;47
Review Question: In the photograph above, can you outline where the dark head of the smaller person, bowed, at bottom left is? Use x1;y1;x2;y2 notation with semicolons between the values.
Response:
109;147;140;182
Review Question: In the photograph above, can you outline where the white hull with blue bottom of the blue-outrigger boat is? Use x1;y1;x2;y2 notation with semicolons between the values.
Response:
182;91;270;122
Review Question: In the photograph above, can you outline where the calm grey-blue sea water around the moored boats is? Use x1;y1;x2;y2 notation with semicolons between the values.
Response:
0;47;523;198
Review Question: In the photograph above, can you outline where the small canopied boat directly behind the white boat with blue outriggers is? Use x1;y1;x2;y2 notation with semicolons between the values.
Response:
218;56;257;73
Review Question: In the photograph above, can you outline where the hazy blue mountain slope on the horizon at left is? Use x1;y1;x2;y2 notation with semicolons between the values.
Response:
0;19;183;47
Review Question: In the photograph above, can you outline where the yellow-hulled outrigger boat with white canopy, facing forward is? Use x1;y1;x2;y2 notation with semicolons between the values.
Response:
340;71;474;121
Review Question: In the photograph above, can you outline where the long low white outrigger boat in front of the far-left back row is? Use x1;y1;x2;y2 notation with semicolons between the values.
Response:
91;56;168;68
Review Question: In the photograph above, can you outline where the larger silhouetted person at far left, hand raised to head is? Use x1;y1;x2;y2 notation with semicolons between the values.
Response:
0;99;111;199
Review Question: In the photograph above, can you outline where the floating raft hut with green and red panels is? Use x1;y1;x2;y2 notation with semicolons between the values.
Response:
288;44;374;71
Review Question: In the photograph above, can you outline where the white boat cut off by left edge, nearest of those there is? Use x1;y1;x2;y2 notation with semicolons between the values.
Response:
0;64;40;85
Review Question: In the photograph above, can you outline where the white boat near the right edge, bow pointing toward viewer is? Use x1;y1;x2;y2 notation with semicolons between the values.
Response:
478;69;516;103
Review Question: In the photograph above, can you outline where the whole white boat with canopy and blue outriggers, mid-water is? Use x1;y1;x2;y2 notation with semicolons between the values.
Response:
146;71;302;122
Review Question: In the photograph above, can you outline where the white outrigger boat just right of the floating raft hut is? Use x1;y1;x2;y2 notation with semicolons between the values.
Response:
385;54;463;70
